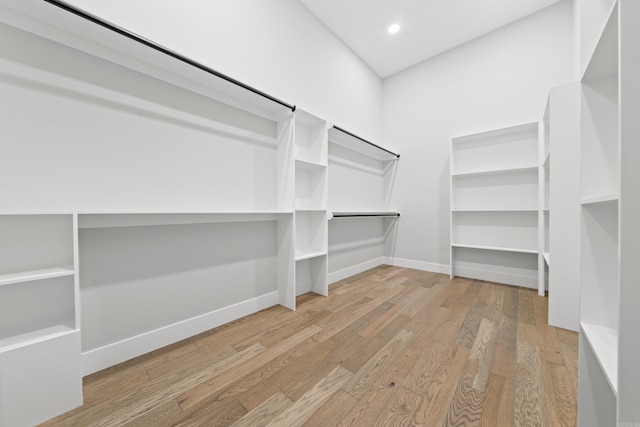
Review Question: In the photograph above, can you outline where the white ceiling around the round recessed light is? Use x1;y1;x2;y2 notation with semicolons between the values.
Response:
300;0;562;78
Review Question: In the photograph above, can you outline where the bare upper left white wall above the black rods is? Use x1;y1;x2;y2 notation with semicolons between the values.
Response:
70;0;382;140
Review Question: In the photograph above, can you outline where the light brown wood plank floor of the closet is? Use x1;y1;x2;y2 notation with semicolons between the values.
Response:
45;266;578;427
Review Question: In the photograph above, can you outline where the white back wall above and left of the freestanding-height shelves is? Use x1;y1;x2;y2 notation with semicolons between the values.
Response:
383;1;575;272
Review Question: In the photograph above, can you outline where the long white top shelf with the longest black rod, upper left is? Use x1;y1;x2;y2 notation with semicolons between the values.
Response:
0;0;295;120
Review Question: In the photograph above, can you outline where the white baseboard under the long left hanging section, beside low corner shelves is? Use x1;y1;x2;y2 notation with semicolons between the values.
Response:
82;292;278;376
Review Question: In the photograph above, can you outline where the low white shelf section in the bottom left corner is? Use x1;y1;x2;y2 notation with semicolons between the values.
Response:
0;214;82;426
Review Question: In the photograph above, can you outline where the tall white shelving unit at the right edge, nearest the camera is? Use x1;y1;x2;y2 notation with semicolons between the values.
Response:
578;0;640;426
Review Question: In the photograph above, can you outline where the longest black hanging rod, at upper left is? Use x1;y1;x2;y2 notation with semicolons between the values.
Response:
44;0;296;111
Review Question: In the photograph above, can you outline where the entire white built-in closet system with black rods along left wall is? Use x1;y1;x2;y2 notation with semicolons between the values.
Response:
0;0;399;426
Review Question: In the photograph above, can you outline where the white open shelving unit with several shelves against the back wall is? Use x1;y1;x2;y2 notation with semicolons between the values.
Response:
450;122;544;292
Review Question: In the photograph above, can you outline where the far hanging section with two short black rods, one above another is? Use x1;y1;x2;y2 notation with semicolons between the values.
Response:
328;126;400;283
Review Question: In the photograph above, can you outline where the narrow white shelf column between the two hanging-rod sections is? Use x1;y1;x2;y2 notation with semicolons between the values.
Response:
294;109;329;296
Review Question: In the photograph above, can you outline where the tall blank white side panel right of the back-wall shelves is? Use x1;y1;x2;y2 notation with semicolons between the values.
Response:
541;82;580;331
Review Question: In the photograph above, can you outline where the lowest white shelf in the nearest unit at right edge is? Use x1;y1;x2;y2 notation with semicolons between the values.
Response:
580;322;618;395
